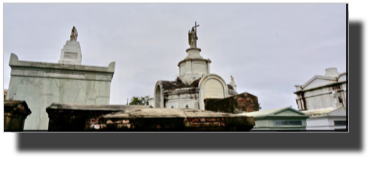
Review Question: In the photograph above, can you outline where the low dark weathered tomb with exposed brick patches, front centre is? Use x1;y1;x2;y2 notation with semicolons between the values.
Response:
92;108;255;131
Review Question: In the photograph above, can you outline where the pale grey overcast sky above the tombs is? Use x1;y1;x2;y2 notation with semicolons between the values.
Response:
2;3;346;110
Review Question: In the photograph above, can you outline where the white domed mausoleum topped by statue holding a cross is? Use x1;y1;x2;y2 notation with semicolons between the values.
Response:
152;24;237;110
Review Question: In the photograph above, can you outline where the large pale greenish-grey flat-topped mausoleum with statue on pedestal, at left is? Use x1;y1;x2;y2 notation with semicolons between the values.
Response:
6;27;115;130
